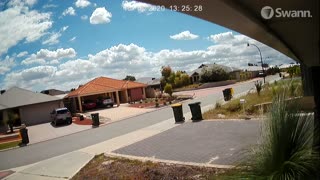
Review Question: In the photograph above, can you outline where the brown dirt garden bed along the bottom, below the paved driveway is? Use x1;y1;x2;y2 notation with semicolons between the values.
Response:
72;154;230;180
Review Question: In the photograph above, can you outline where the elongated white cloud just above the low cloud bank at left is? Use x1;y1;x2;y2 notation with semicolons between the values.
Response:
21;48;76;65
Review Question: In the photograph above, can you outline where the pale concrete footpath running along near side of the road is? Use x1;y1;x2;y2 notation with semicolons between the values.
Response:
4;113;191;180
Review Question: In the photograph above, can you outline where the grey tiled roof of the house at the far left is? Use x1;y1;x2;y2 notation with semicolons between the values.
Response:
0;87;61;110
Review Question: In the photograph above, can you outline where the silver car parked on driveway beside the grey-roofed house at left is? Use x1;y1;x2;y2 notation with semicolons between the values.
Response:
50;108;72;126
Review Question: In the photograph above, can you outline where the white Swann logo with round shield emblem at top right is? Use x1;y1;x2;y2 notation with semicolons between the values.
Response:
261;6;312;19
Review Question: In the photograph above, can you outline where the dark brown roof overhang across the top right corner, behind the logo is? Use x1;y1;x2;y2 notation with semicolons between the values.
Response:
139;0;320;66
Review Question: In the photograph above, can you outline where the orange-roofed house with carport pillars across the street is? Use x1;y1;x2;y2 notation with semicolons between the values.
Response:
65;77;147;112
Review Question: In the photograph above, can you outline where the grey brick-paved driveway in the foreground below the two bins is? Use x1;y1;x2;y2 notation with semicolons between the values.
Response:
113;120;261;165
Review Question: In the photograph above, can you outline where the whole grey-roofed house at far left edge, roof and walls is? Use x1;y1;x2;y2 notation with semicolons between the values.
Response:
0;87;64;126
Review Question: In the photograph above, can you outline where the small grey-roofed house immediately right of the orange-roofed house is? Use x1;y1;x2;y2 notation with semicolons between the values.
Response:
136;77;161;98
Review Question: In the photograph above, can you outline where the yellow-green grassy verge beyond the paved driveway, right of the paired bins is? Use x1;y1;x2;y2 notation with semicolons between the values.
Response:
203;79;303;119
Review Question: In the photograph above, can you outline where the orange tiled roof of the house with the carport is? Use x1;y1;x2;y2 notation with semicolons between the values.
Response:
67;77;147;97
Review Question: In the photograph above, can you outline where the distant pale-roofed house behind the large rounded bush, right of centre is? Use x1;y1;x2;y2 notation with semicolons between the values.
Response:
188;64;241;84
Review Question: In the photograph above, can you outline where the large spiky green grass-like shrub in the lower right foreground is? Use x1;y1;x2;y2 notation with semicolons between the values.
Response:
244;93;320;180
